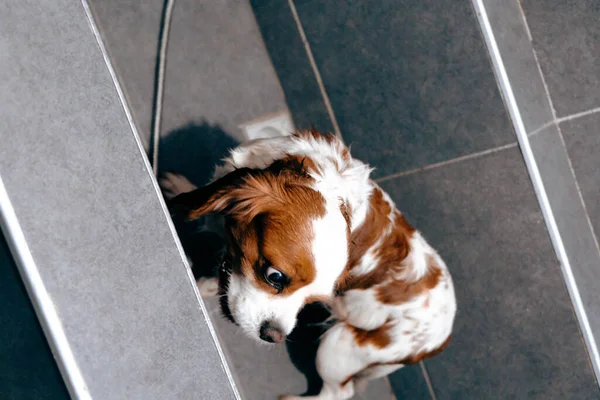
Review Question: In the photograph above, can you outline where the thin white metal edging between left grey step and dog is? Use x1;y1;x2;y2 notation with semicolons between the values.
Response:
81;0;242;400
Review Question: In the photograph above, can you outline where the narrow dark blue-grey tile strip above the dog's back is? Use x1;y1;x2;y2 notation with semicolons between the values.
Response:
250;0;333;132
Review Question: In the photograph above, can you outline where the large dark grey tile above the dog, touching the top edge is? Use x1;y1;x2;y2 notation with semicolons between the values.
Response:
292;0;514;176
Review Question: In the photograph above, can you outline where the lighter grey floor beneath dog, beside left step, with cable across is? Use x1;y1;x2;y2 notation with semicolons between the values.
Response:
85;0;392;400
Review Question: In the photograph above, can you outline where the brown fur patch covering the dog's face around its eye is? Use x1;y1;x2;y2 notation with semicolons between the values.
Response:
175;157;325;295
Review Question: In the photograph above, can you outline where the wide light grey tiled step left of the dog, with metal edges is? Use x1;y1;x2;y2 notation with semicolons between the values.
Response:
0;0;240;400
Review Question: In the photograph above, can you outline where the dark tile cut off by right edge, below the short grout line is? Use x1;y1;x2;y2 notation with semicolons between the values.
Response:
561;114;600;262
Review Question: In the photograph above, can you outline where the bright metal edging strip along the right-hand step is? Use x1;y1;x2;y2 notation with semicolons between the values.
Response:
472;0;600;377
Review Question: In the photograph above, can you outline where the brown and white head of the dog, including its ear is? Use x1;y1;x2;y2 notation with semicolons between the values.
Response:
170;156;350;342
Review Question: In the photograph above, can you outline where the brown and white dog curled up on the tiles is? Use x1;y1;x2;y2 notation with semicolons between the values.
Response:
161;130;456;400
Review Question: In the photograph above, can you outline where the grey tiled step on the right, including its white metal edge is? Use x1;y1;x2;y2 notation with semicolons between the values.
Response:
479;0;600;382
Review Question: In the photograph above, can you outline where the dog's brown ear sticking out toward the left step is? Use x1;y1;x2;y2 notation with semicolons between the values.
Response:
167;168;252;220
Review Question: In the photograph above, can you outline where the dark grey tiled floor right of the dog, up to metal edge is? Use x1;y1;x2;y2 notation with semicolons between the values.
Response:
252;0;600;399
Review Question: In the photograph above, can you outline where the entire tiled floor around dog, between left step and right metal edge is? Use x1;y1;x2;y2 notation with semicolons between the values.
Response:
84;0;600;399
